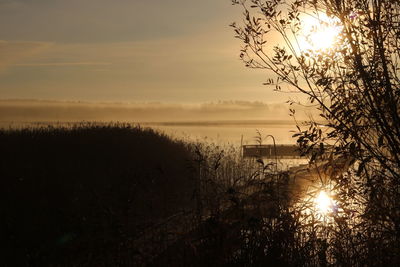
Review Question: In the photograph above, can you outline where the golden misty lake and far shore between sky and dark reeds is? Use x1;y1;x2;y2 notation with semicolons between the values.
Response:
0;100;304;145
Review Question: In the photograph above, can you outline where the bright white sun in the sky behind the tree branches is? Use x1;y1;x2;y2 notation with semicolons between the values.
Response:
299;14;342;51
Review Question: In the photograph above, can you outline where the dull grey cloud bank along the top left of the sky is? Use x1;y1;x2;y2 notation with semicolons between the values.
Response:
0;0;229;43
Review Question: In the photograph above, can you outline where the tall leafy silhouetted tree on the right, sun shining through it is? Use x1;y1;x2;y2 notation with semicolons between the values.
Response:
232;0;400;263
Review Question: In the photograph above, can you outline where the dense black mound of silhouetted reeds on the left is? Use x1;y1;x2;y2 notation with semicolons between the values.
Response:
0;123;194;266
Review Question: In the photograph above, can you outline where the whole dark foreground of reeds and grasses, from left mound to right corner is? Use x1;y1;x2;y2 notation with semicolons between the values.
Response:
0;124;400;266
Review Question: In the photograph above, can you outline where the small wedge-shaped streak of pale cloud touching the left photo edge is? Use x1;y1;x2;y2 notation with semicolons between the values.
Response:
0;40;53;69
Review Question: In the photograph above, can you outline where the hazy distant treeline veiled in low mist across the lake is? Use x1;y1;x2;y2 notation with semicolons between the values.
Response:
0;99;316;122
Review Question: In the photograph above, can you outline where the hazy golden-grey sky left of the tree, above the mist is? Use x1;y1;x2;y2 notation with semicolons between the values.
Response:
0;0;300;103
